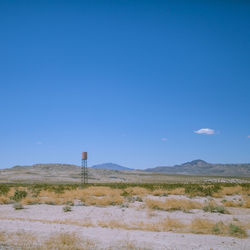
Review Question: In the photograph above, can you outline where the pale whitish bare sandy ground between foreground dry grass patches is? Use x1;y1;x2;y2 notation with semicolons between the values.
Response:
0;202;250;250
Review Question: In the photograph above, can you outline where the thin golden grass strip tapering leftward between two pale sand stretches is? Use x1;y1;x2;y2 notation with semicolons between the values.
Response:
0;217;246;239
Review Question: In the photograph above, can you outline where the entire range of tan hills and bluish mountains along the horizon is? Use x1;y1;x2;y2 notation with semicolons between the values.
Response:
0;160;250;183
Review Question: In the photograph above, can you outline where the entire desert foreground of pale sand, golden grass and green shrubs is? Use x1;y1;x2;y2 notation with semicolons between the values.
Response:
0;183;250;249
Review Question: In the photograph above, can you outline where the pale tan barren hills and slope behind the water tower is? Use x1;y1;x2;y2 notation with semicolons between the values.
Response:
0;164;250;183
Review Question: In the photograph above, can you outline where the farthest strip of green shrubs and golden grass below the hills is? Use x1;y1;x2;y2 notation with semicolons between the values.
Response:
0;183;247;199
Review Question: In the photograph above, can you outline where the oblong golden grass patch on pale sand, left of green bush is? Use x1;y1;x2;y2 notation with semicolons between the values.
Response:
146;199;202;212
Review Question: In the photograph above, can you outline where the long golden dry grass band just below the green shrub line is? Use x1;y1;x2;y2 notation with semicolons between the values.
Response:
0;185;249;207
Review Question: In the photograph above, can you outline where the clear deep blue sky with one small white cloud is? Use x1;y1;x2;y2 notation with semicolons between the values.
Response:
0;0;250;168
